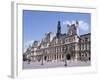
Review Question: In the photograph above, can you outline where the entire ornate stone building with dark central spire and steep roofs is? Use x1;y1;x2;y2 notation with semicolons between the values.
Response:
25;21;91;62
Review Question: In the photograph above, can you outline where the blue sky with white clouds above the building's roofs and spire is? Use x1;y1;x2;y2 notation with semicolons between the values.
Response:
23;10;91;50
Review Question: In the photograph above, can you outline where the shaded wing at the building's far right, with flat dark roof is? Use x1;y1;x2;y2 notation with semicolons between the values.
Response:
79;33;91;60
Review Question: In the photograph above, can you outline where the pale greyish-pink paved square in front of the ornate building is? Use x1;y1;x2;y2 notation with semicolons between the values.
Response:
23;61;91;69
